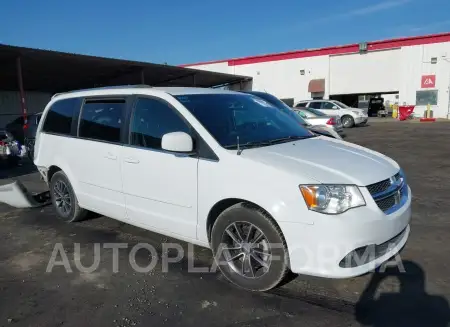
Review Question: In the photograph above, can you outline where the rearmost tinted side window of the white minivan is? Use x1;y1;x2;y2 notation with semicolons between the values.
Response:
42;98;79;135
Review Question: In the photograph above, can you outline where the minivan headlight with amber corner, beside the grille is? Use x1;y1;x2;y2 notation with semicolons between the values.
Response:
300;185;366;214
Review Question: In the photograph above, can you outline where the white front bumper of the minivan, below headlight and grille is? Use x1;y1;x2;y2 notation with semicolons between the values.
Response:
279;187;411;278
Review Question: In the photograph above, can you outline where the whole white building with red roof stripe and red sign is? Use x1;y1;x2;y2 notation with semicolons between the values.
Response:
183;33;450;118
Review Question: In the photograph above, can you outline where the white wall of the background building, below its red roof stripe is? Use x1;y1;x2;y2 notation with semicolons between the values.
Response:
185;38;450;118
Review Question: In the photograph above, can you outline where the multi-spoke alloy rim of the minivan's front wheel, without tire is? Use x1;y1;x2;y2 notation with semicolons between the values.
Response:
221;222;272;278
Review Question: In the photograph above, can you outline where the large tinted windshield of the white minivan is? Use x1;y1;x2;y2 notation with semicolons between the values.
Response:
175;93;315;149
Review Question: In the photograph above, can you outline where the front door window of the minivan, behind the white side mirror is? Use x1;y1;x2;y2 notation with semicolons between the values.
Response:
130;98;190;149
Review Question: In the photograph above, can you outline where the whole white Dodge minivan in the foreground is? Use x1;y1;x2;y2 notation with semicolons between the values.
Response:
34;86;411;291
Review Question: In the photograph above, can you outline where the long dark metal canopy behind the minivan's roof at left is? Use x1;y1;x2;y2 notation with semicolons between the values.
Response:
0;44;251;93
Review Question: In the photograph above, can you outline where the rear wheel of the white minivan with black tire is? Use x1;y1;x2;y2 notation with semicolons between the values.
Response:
50;171;88;223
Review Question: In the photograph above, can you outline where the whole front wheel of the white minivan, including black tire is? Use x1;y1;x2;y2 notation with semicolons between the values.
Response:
211;203;289;291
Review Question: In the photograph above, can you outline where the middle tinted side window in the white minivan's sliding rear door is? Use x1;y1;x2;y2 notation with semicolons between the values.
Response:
78;99;125;143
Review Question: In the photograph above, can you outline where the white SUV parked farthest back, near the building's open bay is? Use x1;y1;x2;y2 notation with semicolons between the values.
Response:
294;100;368;128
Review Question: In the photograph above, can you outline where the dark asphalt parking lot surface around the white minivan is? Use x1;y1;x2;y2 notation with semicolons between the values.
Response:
0;122;450;327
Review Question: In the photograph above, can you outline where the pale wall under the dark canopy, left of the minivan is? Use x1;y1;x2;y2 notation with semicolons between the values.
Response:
0;91;52;128
